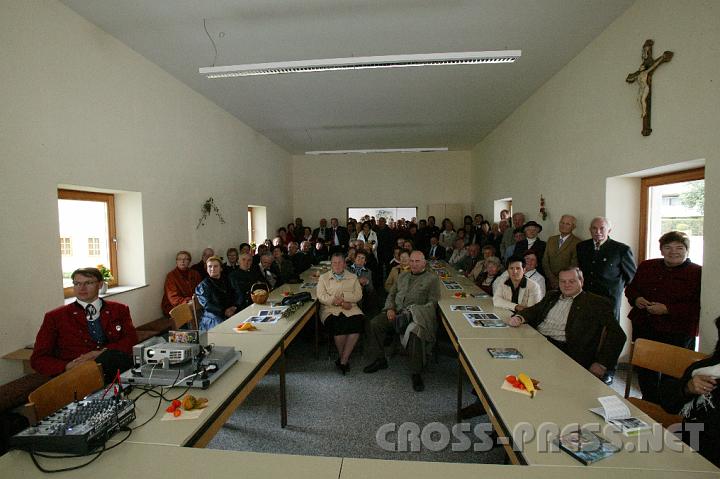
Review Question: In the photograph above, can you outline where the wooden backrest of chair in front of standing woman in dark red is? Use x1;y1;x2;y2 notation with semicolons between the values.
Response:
625;339;707;397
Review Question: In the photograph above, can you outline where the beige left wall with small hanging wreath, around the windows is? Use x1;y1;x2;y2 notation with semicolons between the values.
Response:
0;0;292;383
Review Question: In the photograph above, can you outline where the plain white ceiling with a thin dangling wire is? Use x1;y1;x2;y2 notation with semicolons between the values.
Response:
61;0;634;154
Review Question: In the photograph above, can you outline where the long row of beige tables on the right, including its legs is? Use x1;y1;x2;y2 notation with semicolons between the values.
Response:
430;262;717;472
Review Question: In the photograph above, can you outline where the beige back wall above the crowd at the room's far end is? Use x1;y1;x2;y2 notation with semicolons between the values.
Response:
292;151;476;228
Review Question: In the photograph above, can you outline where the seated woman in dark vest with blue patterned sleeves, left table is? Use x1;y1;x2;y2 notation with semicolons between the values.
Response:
195;256;238;331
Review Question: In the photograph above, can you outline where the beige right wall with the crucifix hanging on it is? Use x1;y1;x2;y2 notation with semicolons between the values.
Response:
472;0;720;351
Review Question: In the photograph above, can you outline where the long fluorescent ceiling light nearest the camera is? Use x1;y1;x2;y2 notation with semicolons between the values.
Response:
199;50;521;78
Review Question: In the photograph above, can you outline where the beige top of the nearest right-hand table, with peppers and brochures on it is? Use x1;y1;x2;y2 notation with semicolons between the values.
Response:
460;338;717;471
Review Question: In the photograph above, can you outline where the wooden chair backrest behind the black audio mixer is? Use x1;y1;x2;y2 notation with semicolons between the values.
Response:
25;361;103;424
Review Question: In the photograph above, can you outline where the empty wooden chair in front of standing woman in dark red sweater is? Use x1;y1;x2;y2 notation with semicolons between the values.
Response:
625;339;707;427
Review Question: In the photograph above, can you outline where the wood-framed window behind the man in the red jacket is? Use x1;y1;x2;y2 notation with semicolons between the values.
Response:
58;189;119;297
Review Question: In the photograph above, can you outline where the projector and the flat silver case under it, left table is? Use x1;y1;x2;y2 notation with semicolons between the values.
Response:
120;338;242;389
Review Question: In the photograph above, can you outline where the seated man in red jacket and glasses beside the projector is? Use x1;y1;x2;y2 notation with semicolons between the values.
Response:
30;268;138;383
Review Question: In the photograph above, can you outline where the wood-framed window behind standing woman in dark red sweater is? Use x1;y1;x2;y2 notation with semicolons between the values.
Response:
638;168;705;264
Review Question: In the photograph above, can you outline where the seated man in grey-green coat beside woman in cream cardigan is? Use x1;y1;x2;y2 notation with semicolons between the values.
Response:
363;251;440;392
